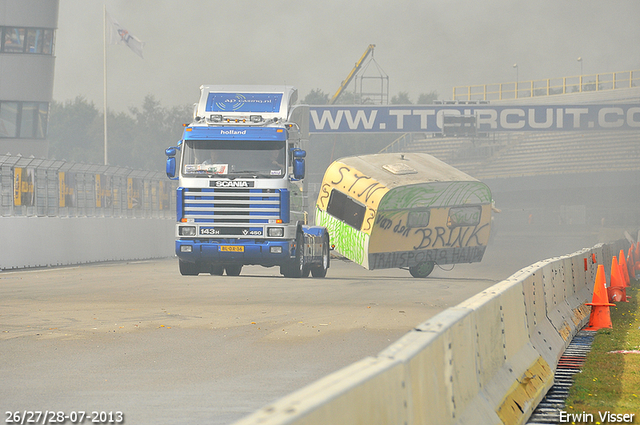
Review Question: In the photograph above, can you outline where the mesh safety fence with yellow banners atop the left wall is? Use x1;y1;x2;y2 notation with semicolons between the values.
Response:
0;155;176;218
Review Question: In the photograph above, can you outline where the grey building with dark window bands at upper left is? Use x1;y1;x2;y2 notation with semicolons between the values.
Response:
0;0;59;158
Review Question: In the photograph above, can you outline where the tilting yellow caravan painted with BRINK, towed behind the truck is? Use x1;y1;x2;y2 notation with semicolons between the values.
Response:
316;153;491;276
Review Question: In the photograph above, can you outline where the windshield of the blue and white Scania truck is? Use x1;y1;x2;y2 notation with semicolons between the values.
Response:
182;140;286;178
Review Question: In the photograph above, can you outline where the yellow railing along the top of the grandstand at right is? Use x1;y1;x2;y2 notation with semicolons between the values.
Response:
453;70;640;100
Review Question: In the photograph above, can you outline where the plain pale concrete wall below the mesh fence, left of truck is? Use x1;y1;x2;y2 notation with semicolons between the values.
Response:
0;217;175;269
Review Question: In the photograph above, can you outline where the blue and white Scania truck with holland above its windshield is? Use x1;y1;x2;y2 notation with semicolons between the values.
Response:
165;85;330;277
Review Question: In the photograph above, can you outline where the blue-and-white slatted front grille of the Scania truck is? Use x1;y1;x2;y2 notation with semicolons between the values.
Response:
183;188;281;224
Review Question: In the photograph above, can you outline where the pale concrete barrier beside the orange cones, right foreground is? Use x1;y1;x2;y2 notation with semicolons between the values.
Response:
235;240;629;425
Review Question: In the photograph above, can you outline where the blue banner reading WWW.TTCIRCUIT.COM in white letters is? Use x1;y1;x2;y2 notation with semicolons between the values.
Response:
309;104;640;133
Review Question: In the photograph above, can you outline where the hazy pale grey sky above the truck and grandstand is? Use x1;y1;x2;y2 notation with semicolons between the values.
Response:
53;0;640;111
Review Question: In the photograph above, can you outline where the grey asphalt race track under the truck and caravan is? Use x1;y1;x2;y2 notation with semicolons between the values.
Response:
0;224;597;425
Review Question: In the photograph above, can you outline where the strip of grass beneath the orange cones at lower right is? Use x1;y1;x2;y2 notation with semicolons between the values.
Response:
565;274;640;424
